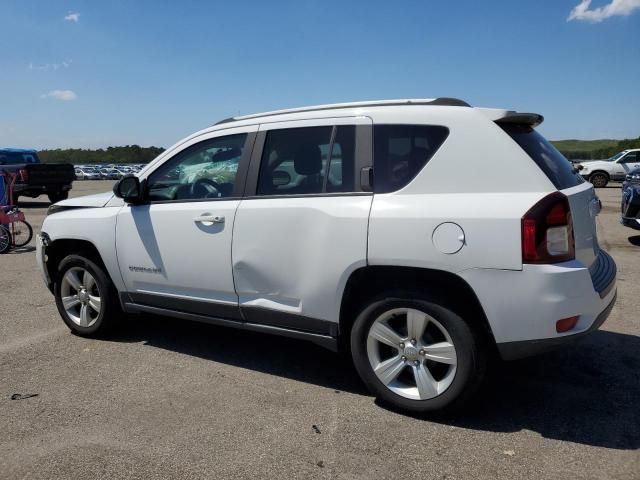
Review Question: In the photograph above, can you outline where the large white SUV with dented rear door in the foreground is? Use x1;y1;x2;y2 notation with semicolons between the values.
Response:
37;98;616;411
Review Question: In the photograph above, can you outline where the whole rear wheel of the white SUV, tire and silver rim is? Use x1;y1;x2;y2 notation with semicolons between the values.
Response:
351;294;487;413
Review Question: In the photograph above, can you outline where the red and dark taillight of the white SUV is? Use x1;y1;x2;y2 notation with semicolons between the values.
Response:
522;192;576;263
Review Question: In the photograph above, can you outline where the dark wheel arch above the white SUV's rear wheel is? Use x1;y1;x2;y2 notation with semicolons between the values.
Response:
338;266;495;350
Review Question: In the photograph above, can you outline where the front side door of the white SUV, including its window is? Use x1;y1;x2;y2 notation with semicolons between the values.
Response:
116;127;257;319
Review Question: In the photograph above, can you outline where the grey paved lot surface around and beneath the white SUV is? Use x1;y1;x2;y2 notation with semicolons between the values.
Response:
0;182;640;480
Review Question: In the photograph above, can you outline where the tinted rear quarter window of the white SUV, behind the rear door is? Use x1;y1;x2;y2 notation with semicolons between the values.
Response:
373;125;449;193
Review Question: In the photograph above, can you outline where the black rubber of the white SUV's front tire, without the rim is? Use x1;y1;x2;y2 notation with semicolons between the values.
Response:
54;255;124;337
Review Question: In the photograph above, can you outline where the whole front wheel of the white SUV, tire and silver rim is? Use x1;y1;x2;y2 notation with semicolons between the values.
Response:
54;255;123;337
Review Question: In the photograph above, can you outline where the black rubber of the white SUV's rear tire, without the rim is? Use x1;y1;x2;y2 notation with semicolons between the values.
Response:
351;293;488;413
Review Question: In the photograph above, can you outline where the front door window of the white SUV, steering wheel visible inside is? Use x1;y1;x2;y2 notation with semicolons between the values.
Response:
147;133;247;201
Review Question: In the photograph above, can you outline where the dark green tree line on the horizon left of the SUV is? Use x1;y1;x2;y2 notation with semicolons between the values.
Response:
38;145;165;165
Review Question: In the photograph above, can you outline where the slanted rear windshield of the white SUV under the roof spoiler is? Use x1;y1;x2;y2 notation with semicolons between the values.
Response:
499;124;584;190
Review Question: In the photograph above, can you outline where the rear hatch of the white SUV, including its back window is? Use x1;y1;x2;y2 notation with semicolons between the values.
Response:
496;122;600;267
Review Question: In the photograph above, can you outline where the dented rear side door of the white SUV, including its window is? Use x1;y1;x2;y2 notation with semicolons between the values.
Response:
232;117;372;335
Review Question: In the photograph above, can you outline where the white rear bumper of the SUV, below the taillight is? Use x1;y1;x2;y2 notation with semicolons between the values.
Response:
461;251;616;360
